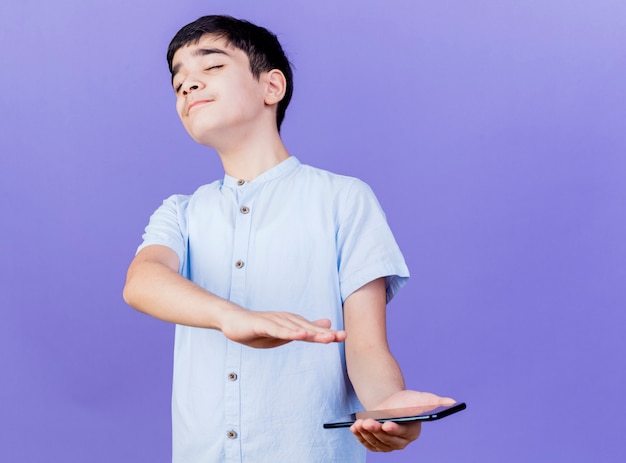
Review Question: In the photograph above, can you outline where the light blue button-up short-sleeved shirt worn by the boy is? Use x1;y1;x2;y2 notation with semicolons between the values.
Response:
140;157;409;463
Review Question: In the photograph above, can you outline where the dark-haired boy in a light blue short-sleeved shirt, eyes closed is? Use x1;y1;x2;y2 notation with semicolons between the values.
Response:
124;16;453;463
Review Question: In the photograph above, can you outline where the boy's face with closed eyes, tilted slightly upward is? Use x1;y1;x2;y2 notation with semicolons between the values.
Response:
172;35;267;146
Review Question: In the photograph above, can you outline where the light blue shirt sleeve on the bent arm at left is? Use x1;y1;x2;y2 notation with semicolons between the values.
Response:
137;195;189;272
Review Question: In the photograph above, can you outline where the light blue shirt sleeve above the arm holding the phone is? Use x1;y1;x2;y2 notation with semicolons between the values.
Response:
337;179;409;302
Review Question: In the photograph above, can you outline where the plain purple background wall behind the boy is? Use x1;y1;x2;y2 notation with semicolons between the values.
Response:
0;0;626;463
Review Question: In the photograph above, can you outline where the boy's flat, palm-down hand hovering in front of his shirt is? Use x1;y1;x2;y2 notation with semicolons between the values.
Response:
221;309;346;348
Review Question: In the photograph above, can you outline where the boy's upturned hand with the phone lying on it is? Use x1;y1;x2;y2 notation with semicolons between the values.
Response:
350;390;455;452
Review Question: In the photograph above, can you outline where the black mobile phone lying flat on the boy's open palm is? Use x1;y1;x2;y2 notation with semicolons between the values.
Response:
324;402;467;429
